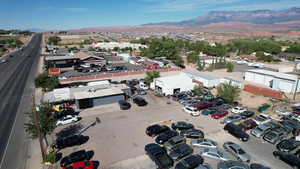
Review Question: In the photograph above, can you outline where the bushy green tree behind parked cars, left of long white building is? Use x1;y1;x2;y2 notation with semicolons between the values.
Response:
217;83;241;103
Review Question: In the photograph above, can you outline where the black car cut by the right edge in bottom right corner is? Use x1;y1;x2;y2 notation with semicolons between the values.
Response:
273;151;300;169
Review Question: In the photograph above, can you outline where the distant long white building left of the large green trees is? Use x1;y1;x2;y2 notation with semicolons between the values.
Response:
94;42;147;49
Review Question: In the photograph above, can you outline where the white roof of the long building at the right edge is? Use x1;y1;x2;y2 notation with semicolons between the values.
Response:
247;69;298;81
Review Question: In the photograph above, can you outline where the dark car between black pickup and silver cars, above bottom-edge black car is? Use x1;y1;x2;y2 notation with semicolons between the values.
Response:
169;144;193;160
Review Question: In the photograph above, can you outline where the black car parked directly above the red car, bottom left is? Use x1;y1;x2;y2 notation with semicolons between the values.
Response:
60;150;94;167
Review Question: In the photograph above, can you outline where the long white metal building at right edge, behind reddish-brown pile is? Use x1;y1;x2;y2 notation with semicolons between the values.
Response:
245;69;300;93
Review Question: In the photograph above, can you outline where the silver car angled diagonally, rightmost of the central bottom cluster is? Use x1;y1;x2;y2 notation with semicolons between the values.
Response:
223;141;251;163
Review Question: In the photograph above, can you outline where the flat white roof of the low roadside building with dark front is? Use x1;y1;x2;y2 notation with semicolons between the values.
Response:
74;88;124;100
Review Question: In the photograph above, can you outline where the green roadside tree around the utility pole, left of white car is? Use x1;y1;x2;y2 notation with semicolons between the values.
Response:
25;103;56;146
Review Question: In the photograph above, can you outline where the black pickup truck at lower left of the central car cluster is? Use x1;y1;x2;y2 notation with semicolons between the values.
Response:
145;143;174;169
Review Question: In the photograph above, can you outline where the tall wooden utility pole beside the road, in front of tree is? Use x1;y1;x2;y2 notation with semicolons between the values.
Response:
32;96;47;160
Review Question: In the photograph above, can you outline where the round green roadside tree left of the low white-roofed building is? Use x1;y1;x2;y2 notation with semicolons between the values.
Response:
34;73;59;91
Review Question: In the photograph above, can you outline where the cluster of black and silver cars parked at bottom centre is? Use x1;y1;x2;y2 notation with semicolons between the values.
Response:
145;121;269;169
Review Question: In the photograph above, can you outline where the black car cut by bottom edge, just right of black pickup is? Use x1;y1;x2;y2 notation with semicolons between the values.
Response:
175;154;204;169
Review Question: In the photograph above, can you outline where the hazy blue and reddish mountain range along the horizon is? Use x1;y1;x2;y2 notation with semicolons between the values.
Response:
73;7;300;34
